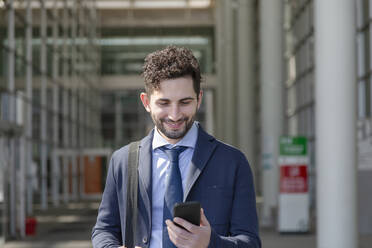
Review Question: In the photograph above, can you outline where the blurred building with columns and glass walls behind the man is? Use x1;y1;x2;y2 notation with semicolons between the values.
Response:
0;0;372;248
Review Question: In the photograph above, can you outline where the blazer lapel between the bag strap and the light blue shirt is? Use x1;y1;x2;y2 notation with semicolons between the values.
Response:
138;131;153;227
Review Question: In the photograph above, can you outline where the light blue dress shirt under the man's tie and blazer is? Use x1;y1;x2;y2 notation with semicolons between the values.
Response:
150;122;198;248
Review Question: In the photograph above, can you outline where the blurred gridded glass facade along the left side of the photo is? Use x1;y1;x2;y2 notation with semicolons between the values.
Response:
0;0;102;237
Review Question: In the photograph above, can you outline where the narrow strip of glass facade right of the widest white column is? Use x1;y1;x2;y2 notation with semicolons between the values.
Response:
356;0;372;233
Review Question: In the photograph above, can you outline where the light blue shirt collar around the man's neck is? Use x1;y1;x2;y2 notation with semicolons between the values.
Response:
152;121;198;150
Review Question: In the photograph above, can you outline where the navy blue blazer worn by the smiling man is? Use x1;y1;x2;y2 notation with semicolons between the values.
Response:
92;126;261;248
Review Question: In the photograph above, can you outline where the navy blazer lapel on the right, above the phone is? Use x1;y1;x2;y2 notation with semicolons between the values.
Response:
183;125;217;201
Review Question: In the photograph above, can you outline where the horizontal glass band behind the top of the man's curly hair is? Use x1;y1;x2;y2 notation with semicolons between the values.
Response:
100;35;213;75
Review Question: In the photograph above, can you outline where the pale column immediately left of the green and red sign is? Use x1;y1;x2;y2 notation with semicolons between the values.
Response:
260;0;283;226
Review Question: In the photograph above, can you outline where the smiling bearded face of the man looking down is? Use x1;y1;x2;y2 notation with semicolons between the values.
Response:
141;77;203;144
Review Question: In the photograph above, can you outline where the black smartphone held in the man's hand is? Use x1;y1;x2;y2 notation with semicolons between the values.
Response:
173;201;200;226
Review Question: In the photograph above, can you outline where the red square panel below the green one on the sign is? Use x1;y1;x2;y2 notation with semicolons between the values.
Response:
280;165;308;193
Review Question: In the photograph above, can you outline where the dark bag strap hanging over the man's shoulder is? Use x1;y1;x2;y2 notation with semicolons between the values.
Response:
125;141;140;248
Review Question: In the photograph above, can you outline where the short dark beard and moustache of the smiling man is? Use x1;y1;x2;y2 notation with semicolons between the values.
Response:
151;114;195;139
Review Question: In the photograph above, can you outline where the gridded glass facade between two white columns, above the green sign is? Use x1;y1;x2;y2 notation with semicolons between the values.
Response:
284;0;315;204
